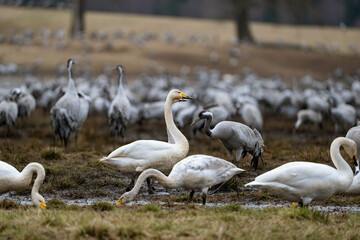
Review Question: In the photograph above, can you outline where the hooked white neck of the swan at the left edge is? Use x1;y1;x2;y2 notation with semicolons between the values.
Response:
20;163;45;202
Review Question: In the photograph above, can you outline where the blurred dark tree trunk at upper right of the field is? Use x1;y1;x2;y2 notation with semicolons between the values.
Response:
233;0;254;42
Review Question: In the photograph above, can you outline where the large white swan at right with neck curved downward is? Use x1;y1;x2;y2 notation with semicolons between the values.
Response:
245;137;356;205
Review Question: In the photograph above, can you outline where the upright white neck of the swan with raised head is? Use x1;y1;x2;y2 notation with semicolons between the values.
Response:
164;95;189;148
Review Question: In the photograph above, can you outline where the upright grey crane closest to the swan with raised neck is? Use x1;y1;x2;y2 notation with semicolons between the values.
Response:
108;65;131;138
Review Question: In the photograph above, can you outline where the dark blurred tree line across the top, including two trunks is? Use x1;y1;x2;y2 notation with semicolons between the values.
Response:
0;0;360;41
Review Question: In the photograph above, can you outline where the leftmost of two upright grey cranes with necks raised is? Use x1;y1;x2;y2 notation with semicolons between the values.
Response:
50;59;80;147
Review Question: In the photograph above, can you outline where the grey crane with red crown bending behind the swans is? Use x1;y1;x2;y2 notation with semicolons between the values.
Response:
192;110;264;170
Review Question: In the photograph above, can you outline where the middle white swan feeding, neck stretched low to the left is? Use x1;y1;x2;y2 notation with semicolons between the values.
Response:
116;155;245;205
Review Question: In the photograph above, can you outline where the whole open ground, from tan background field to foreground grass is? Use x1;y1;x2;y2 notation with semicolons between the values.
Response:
0;7;360;239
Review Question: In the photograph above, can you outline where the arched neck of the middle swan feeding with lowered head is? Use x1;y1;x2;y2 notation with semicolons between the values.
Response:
126;169;176;201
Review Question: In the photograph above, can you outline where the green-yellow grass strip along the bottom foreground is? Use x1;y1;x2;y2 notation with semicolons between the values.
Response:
0;203;360;239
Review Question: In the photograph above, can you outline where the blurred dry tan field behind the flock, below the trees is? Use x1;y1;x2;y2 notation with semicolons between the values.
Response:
0;7;360;80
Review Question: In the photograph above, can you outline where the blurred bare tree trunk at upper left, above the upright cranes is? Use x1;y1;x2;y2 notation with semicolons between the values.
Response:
71;0;85;38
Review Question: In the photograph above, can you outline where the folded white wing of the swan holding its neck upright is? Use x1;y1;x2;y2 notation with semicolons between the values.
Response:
106;140;174;160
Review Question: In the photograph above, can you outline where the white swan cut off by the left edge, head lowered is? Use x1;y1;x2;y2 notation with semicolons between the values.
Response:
0;161;46;208
